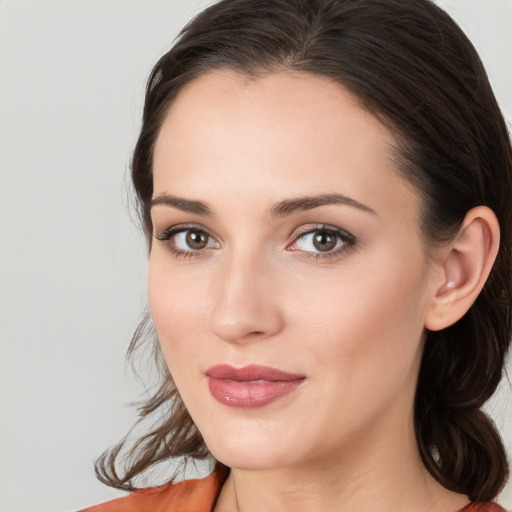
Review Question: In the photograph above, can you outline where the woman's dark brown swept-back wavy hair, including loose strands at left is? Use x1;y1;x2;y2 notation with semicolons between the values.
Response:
96;0;512;500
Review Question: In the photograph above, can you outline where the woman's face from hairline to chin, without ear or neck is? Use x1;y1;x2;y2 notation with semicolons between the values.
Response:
148;71;435;469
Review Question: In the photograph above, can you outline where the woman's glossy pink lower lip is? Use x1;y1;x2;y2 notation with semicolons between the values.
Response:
208;377;304;409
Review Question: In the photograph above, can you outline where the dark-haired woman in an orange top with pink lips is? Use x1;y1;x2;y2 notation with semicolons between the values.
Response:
82;0;512;512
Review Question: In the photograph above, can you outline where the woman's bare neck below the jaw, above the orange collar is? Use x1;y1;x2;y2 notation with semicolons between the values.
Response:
215;412;468;512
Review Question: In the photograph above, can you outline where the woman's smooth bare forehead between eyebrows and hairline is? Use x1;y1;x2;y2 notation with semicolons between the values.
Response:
153;71;416;222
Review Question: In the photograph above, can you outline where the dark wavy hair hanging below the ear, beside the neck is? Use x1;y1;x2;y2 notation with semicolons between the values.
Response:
414;306;508;501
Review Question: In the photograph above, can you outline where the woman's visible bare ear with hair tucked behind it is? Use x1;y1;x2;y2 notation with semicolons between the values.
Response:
425;206;500;331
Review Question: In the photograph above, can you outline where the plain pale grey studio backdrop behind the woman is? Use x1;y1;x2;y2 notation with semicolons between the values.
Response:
0;0;512;512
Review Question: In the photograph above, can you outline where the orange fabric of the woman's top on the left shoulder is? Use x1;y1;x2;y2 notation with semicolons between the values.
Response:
80;472;224;512
